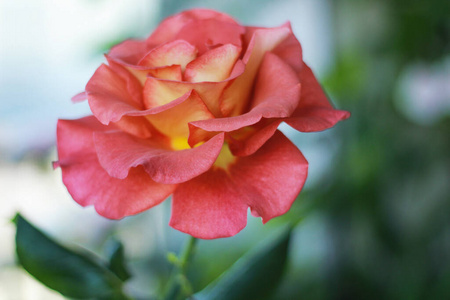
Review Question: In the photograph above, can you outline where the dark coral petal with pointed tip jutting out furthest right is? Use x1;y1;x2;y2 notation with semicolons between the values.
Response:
285;64;350;132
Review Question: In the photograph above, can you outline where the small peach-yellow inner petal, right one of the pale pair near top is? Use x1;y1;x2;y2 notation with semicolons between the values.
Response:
184;44;241;82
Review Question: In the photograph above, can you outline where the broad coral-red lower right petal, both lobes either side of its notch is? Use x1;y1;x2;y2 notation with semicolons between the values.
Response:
170;132;308;239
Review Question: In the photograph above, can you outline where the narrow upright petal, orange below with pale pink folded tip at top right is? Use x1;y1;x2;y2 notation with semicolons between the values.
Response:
220;26;290;116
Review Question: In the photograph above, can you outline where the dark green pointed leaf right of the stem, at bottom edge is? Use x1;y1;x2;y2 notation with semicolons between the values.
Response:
192;228;291;300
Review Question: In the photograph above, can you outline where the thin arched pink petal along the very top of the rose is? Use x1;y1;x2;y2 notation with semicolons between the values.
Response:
147;9;241;45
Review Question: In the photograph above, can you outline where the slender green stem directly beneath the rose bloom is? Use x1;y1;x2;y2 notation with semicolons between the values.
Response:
162;236;197;300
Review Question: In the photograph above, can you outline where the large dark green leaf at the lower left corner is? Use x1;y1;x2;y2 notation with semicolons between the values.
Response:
14;214;126;299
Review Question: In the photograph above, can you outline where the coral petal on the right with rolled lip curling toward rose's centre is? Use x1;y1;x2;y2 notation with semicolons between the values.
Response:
190;53;300;143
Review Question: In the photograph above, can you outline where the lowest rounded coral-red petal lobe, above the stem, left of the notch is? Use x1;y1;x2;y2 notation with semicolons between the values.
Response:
169;169;248;239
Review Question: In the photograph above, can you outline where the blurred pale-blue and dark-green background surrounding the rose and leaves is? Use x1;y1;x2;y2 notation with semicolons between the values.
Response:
0;0;450;299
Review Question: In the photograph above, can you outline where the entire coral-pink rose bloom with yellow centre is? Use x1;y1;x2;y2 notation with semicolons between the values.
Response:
55;9;349;239
